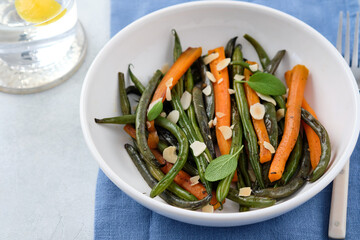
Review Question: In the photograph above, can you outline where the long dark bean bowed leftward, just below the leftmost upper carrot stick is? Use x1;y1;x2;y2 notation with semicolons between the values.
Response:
135;70;162;167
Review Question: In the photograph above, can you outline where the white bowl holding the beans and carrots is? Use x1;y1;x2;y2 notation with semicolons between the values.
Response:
80;2;360;226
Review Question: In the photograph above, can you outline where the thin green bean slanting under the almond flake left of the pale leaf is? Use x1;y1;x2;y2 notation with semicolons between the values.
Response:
171;91;211;194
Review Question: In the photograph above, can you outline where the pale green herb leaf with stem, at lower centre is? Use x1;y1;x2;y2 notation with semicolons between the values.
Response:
205;146;243;182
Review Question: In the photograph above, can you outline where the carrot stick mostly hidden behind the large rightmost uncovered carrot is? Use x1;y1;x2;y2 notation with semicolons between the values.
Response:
285;71;321;169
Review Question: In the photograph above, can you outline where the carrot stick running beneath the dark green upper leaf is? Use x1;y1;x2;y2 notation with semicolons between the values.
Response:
244;62;271;163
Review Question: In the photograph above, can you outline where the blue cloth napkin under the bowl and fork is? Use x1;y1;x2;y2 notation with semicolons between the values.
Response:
95;0;360;240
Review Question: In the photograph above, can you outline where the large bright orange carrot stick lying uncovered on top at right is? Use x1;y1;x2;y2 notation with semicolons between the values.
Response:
269;65;309;182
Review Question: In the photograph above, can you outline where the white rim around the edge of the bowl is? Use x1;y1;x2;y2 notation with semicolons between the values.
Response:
80;1;360;227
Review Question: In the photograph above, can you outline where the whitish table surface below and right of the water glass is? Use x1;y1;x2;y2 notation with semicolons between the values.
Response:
0;0;110;240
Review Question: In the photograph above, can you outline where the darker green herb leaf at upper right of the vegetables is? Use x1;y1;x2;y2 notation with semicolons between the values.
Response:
247;72;286;96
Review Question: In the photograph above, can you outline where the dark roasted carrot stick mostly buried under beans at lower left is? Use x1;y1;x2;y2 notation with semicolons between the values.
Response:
124;124;220;209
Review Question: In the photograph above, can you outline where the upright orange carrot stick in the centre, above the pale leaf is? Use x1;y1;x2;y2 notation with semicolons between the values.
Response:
208;47;231;155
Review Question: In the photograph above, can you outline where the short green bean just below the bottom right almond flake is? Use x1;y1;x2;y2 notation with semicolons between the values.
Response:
227;188;276;208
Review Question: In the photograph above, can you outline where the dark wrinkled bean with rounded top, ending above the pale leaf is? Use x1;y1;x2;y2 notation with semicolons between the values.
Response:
192;87;216;159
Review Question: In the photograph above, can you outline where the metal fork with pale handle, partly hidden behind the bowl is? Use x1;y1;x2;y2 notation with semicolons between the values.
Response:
328;12;360;239
